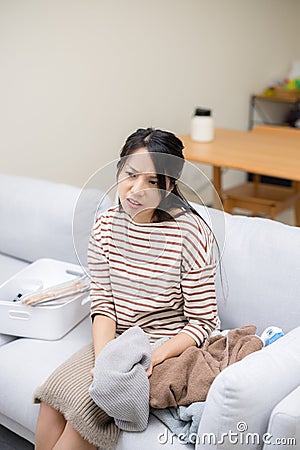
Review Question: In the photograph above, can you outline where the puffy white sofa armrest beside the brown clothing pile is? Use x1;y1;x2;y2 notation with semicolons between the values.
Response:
196;327;300;450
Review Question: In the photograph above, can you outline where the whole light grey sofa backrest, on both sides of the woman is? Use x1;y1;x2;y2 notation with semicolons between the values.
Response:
0;174;300;333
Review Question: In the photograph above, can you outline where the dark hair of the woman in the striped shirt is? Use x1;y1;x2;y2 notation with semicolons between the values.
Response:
117;128;207;225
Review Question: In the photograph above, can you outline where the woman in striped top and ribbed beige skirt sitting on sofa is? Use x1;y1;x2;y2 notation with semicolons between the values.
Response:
36;128;219;450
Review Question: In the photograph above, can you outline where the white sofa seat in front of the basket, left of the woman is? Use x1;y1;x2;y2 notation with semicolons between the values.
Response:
0;317;91;433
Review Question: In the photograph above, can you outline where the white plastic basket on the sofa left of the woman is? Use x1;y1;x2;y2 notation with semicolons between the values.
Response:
0;258;90;340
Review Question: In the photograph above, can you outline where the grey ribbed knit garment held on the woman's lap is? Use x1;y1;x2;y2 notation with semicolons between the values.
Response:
89;327;151;431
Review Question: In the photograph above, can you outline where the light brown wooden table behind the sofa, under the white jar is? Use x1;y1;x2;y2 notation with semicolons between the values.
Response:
180;128;300;222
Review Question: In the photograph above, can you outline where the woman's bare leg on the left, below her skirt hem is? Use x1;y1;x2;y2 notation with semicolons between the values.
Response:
35;403;66;450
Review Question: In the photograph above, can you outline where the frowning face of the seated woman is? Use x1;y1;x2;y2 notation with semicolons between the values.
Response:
118;147;171;223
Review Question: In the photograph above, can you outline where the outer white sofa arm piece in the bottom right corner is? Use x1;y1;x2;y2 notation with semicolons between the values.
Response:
263;386;300;450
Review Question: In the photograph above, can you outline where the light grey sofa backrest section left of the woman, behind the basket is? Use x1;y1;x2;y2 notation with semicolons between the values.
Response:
0;174;111;264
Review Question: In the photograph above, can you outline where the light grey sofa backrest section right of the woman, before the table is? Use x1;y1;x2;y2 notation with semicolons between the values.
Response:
194;204;300;333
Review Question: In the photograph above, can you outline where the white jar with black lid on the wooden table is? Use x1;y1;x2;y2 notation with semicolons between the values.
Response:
191;108;214;142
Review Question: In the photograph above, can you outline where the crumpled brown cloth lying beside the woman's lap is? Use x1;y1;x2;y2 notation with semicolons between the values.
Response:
150;325;263;408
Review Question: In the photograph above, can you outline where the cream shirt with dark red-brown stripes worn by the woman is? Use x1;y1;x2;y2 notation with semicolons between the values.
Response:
88;207;219;345
